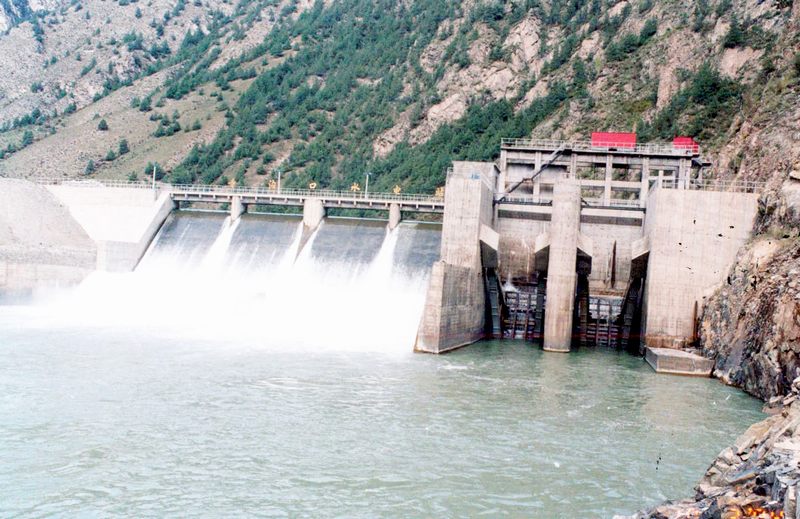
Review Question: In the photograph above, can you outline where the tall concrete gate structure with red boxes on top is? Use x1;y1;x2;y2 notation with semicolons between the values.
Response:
415;139;758;371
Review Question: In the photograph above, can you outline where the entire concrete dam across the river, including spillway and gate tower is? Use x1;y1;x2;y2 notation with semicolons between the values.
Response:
0;140;759;362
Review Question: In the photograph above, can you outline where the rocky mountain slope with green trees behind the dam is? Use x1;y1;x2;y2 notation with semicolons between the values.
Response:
0;0;800;192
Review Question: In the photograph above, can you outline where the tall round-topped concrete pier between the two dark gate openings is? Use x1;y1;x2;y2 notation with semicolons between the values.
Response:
544;178;581;352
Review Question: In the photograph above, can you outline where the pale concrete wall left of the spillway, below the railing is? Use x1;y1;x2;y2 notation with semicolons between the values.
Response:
0;179;173;292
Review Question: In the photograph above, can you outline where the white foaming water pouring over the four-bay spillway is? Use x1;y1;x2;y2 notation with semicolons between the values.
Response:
43;212;440;351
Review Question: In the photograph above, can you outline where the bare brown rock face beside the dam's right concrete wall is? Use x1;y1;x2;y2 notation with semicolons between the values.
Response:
701;178;800;399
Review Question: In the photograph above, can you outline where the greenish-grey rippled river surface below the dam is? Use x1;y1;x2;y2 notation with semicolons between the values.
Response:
0;316;762;518
